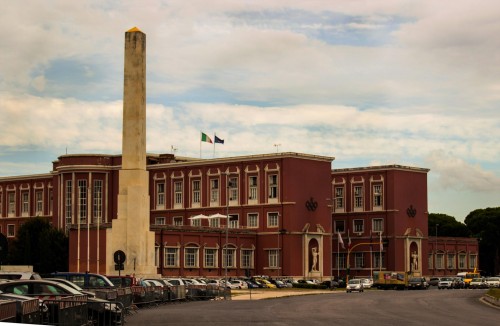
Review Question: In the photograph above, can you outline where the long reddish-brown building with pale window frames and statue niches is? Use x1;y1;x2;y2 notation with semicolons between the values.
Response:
0;153;477;279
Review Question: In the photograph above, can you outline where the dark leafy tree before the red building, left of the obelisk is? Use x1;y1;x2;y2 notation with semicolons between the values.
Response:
8;217;69;274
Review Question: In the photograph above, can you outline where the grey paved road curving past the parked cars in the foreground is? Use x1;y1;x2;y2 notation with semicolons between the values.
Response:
125;290;500;326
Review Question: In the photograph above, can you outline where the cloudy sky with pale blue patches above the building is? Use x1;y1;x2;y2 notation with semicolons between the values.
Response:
0;0;500;220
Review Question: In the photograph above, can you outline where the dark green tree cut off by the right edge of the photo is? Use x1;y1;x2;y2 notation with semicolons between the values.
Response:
465;207;500;275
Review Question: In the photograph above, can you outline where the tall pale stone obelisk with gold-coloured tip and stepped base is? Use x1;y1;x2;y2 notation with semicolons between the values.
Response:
106;27;157;277
